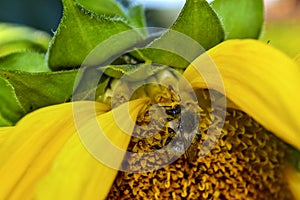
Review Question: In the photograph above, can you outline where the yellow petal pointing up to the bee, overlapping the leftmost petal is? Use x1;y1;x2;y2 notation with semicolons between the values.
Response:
35;100;147;200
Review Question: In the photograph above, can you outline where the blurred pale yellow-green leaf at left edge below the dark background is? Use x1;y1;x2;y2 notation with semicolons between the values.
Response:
0;23;50;56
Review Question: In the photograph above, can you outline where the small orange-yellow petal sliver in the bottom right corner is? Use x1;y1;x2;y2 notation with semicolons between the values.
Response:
284;166;300;200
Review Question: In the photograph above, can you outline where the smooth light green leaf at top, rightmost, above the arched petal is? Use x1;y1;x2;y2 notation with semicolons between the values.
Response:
211;0;264;39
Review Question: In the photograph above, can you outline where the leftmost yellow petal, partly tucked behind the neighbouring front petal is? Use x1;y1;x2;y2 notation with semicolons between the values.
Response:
0;102;109;199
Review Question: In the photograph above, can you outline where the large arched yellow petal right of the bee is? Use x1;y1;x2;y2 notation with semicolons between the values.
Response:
184;40;300;150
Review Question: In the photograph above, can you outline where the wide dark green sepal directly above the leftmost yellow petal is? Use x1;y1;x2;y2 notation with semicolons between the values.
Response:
0;70;77;113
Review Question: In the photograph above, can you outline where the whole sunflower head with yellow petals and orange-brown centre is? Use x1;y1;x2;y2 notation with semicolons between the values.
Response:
0;40;300;200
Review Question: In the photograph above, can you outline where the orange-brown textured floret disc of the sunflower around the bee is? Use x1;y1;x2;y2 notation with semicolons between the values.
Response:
107;90;293;200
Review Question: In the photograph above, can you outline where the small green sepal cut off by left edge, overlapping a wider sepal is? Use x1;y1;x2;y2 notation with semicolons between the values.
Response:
0;77;25;127
